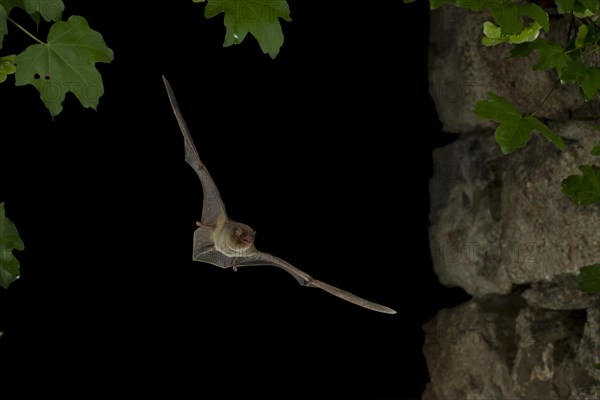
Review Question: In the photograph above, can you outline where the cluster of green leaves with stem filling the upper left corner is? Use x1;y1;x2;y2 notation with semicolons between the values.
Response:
0;0;114;117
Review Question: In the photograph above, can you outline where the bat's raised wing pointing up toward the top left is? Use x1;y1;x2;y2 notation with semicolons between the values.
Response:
163;76;226;227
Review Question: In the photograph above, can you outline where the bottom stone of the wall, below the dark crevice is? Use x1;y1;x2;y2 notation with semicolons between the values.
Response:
423;294;600;400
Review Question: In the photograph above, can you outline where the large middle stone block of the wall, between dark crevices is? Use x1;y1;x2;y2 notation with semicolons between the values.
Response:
430;121;600;296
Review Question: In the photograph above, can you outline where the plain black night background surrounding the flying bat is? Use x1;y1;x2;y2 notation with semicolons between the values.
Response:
0;0;466;398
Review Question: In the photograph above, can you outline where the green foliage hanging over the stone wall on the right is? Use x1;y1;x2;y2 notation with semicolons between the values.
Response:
429;0;600;369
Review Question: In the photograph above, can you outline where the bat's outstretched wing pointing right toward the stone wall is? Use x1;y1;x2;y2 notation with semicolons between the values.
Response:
228;251;396;314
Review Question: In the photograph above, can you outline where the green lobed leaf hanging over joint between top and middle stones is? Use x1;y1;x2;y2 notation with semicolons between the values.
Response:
475;92;565;154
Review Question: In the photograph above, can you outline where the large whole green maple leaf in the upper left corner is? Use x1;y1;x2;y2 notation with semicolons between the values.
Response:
15;15;113;117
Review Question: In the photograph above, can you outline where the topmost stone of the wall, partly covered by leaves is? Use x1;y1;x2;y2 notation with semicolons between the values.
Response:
429;7;600;133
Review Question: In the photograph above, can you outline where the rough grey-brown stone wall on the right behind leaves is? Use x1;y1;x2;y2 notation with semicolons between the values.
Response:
423;3;600;400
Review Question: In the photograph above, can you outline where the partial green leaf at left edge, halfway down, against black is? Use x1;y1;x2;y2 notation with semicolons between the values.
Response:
0;203;25;289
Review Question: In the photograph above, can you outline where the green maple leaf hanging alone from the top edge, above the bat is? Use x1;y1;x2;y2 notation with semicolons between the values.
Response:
193;0;292;58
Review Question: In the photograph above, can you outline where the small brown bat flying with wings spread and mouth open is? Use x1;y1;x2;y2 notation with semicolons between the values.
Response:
163;76;396;314
